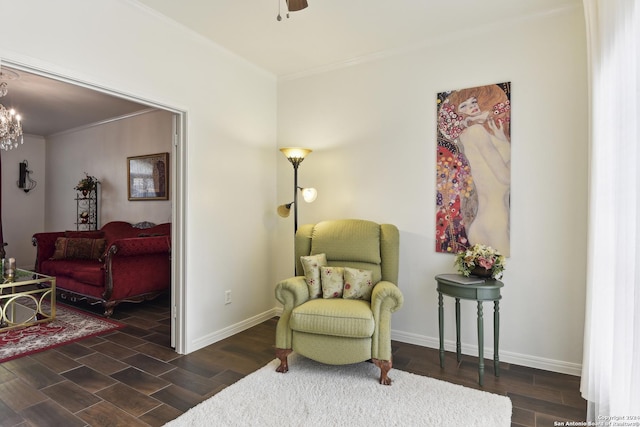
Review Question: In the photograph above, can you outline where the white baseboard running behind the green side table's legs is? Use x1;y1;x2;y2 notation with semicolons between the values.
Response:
391;330;582;377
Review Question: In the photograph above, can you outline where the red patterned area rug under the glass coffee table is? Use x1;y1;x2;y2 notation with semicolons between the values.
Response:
0;304;125;363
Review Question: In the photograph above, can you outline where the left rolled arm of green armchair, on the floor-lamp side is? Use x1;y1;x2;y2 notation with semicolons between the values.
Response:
276;276;309;352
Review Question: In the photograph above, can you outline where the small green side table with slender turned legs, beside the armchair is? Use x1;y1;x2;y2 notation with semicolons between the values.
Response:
436;274;504;385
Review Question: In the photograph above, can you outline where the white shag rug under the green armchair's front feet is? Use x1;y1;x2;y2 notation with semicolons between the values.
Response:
165;354;511;427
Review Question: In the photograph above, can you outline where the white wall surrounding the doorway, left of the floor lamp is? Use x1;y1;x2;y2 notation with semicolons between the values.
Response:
0;0;277;352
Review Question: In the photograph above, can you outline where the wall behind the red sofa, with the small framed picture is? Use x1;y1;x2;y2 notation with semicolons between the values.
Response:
45;110;174;231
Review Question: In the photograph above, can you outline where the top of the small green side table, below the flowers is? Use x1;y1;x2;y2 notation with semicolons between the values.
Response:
435;274;504;301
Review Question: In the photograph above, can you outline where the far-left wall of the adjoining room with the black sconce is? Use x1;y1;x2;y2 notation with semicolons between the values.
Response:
0;135;47;269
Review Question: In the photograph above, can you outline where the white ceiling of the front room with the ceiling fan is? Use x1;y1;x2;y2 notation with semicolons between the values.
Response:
134;0;582;76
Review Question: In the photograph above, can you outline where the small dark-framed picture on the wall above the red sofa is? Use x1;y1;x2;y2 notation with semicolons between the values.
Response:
127;153;169;200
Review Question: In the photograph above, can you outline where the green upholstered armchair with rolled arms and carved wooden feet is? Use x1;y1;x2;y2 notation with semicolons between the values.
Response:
275;219;403;385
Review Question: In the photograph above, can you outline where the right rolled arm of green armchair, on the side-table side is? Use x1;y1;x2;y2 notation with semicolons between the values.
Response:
371;281;404;361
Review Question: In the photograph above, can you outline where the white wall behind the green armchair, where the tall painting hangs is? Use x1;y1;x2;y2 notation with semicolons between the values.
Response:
277;8;587;374
